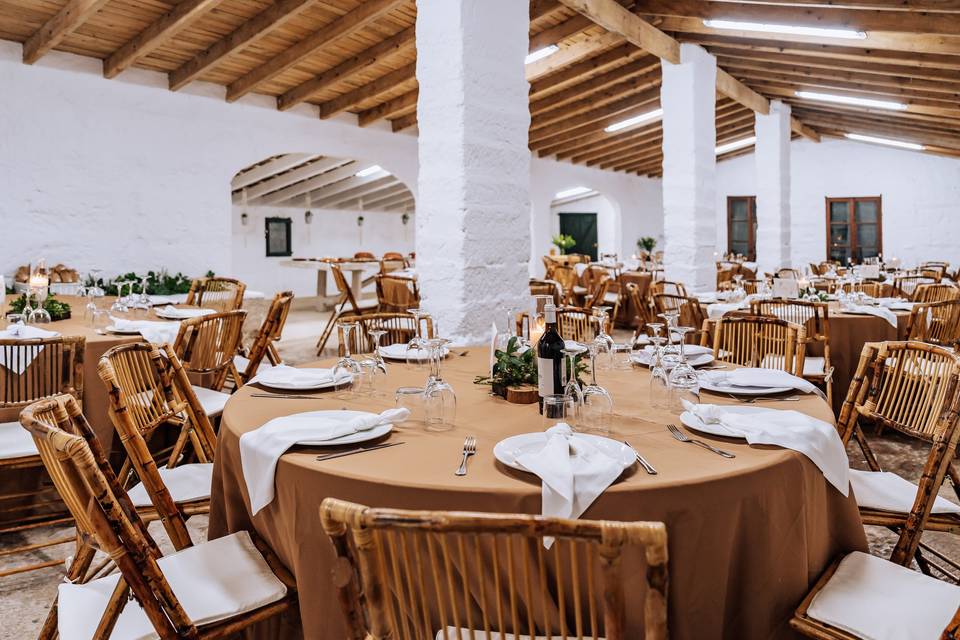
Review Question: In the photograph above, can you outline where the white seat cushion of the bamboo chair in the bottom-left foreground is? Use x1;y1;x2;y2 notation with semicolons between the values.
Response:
57;531;287;640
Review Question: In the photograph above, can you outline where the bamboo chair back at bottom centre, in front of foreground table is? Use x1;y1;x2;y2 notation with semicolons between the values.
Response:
320;498;668;640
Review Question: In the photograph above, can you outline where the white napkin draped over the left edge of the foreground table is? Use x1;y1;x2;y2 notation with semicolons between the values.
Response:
240;407;410;514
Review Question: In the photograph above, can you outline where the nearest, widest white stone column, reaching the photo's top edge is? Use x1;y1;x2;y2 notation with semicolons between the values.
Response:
416;0;530;344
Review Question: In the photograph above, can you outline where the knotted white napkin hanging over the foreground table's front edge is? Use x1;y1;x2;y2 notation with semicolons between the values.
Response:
517;423;623;549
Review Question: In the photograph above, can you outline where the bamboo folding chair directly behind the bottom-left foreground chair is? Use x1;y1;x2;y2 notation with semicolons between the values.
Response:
97;342;216;549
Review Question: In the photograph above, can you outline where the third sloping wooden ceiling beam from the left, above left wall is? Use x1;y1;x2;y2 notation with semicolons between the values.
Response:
170;0;315;91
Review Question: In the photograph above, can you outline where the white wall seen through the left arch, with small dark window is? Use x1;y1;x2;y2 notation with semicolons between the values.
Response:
231;206;416;296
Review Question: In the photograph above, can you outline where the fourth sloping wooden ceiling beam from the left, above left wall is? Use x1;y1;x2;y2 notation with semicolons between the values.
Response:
227;0;406;102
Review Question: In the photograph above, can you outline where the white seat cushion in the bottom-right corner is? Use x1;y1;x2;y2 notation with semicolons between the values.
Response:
807;551;960;640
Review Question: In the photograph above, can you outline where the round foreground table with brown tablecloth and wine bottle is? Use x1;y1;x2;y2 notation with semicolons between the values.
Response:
209;349;867;640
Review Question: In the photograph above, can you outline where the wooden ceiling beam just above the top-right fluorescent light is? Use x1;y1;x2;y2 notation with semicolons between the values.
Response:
633;0;957;35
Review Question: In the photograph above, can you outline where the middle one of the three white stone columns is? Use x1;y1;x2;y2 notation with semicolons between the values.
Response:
660;44;717;290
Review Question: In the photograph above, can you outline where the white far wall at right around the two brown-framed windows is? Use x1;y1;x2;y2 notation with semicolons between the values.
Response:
716;139;960;266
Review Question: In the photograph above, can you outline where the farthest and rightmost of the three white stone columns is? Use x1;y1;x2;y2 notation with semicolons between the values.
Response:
754;100;791;273
